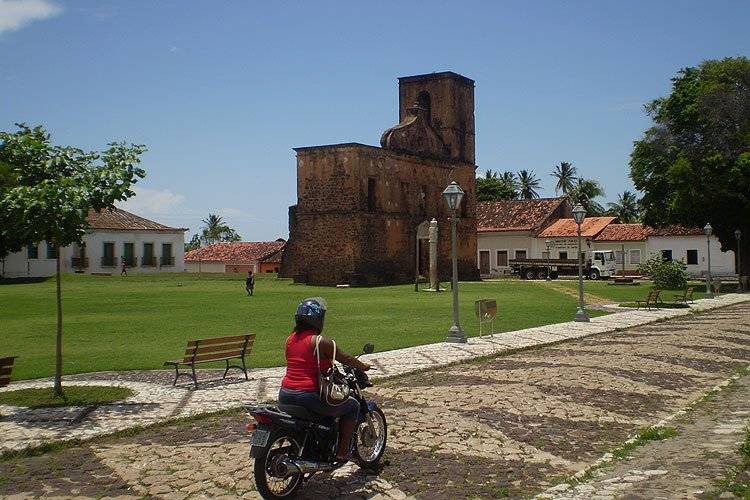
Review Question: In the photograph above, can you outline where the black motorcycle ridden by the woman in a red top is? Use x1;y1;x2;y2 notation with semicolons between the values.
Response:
245;344;388;499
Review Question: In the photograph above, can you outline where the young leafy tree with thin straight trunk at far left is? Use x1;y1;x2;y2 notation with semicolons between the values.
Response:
0;124;146;396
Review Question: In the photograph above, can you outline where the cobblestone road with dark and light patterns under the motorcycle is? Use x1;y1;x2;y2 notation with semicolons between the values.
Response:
0;303;750;499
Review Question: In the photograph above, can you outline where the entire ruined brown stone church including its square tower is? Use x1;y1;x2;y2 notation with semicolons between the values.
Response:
280;72;478;285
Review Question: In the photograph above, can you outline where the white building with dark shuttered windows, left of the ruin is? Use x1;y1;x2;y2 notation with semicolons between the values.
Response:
0;208;187;278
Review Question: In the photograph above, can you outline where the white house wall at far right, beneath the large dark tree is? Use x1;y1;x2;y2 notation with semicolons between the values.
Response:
646;236;736;276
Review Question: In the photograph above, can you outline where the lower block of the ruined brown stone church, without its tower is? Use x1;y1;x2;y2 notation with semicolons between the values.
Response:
281;144;478;285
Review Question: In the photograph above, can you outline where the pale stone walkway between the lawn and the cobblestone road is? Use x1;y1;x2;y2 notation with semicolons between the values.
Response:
0;294;750;452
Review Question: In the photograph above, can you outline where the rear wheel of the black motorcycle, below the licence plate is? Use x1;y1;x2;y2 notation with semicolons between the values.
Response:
253;432;302;499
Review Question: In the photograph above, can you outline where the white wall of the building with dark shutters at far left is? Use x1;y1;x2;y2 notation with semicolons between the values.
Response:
0;231;185;278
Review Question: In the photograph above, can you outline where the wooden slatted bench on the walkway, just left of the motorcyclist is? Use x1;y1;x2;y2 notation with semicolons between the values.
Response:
164;334;255;387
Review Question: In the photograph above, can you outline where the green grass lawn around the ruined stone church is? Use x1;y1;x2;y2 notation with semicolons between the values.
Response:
0;274;688;380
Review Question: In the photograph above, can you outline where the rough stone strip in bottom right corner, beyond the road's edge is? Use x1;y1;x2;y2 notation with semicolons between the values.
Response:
539;376;750;500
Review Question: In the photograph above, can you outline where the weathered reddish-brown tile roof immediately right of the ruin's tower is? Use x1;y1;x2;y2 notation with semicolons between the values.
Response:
477;198;567;233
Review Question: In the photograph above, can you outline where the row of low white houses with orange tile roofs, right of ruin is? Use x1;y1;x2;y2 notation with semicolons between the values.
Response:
477;203;736;277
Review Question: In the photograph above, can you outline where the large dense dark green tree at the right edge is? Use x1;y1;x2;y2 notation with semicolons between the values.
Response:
630;57;750;275
